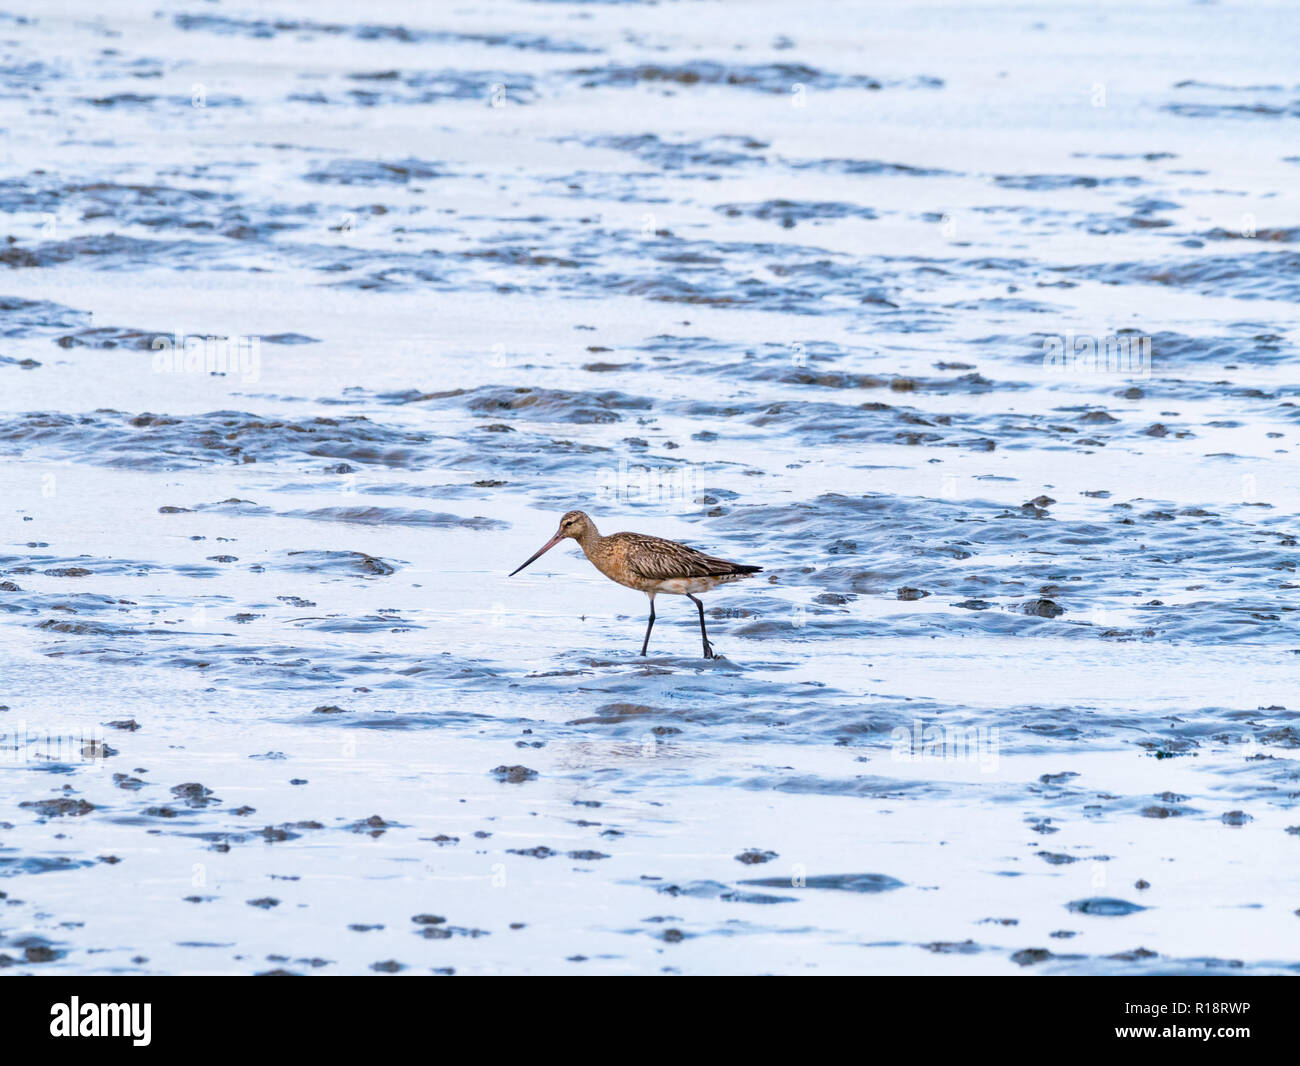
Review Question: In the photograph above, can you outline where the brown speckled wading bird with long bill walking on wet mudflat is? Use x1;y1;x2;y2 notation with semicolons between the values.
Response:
510;511;763;659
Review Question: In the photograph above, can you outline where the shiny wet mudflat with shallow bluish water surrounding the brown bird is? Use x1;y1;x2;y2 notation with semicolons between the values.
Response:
0;0;1300;974
